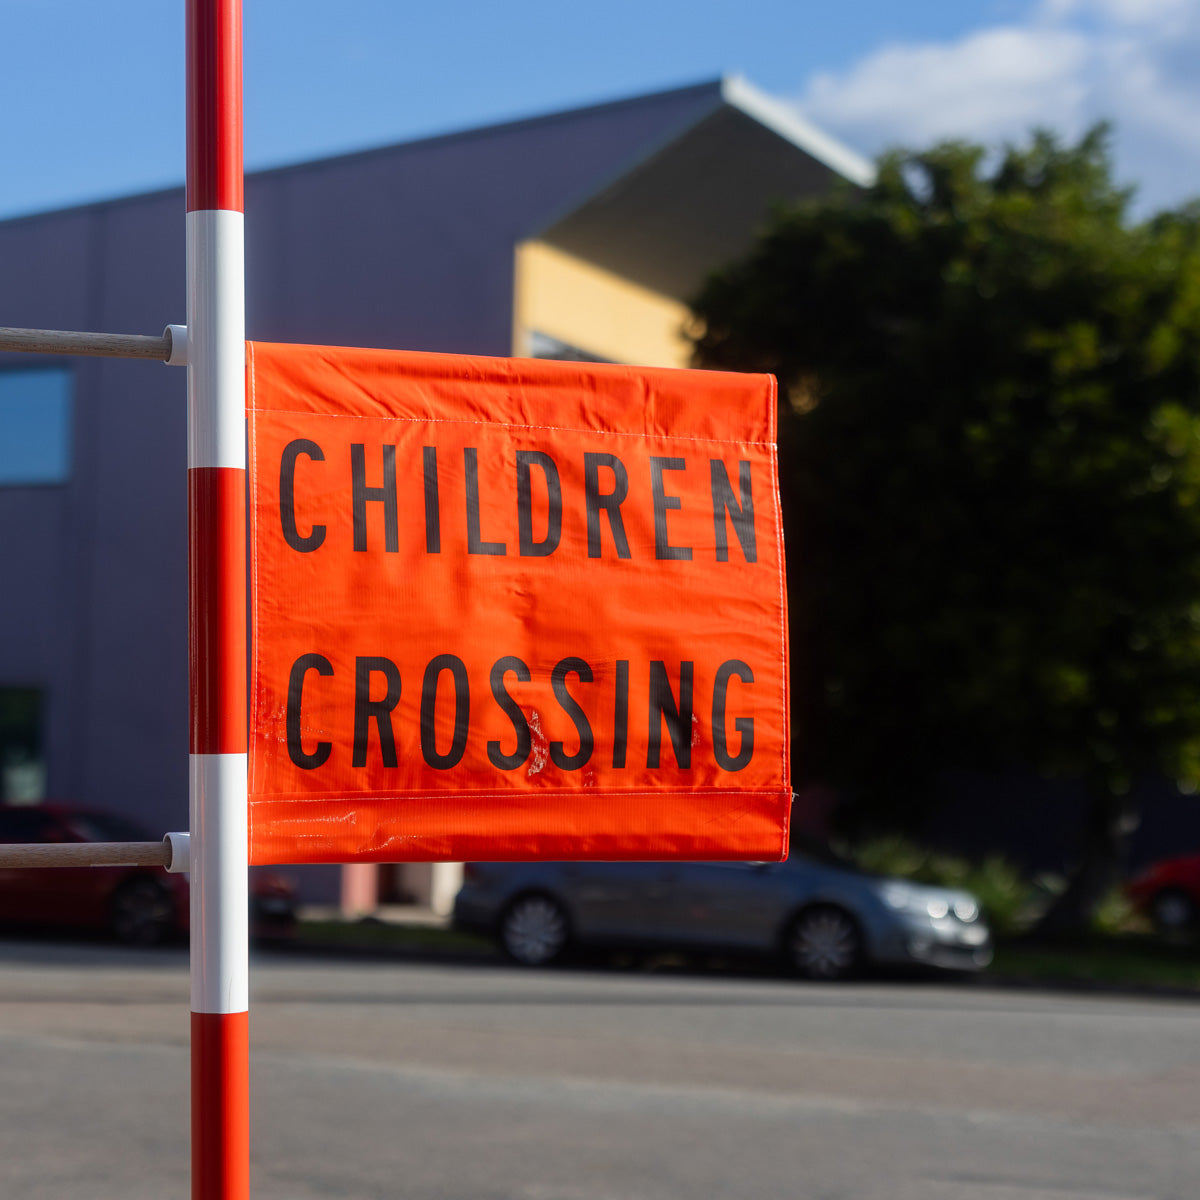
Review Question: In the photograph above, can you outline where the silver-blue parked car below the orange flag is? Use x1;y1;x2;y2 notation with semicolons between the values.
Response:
454;846;991;979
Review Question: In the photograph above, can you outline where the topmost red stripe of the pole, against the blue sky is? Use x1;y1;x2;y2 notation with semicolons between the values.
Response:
187;0;245;212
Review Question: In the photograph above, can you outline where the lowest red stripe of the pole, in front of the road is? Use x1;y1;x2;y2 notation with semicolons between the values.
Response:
192;1013;250;1200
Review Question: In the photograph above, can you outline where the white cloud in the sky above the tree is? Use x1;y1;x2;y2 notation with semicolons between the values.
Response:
799;0;1200;211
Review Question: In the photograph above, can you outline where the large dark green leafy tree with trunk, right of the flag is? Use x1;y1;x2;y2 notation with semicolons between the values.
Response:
694;127;1200;930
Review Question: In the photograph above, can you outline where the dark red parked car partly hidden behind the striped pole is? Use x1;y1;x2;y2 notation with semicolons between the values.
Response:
0;804;296;946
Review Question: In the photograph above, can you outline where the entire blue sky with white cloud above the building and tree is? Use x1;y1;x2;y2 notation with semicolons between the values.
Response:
0;0;1200;217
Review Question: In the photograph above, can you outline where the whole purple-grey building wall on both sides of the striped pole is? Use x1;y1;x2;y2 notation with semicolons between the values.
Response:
0;84;720;892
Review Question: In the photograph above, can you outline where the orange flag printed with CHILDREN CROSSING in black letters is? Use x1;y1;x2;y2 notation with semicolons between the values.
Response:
247;343;791;863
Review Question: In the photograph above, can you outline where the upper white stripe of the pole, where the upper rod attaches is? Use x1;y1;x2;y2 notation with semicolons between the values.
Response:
187;209;246;470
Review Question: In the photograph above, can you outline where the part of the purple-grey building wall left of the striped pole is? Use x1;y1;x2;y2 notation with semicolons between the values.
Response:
0;192;187;832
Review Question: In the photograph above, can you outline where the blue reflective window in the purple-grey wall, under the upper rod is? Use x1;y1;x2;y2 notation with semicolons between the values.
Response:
0;367;73;485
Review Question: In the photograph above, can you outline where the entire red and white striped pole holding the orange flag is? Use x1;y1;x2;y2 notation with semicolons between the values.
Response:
187;0;250;1200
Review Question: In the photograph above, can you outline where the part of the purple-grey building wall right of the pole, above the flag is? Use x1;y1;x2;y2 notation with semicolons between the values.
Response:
238;86;716;355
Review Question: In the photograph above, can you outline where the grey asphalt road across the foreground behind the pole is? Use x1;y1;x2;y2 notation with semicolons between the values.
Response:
0;942;1200;1200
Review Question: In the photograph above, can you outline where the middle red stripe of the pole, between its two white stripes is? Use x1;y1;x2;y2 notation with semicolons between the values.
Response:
187;467;246;754
